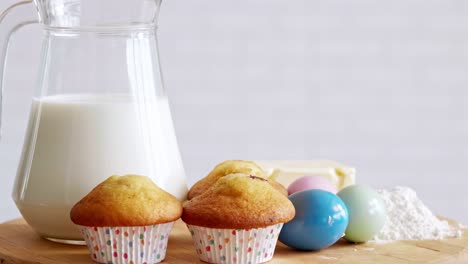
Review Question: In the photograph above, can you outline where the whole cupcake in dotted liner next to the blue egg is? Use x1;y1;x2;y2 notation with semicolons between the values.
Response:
182;173;295;264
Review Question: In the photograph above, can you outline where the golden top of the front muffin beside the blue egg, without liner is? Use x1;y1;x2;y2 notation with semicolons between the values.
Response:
182;173;295;229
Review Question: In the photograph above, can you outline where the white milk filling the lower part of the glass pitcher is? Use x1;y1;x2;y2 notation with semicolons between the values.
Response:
13;95;187;240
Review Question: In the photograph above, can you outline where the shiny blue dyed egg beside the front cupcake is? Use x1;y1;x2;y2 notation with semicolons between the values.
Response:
279;190;348;250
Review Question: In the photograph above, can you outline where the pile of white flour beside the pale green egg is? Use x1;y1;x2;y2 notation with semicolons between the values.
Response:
374;187;462;241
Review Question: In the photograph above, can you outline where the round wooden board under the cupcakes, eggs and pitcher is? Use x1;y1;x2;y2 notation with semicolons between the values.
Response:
0;219;468;264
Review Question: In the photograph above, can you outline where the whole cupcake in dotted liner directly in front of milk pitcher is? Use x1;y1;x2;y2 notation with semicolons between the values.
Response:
70;175;182;264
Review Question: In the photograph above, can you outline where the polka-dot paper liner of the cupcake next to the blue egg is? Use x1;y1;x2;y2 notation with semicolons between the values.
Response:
187;224;283;264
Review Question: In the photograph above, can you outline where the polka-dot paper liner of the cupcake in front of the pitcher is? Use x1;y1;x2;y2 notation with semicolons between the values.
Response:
78;222;174;264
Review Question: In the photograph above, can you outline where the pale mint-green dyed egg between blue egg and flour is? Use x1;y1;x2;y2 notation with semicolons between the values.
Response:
338;185;387;242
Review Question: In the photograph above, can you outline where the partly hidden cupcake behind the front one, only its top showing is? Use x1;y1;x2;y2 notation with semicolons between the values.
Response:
187;160;288;199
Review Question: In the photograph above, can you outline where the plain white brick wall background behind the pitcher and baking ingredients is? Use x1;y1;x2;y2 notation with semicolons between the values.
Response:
0;0;468;223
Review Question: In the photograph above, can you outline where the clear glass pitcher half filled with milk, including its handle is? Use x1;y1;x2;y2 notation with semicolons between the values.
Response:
0;0;187;243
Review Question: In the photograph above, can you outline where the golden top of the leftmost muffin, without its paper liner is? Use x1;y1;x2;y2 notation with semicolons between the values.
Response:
70;175;182;227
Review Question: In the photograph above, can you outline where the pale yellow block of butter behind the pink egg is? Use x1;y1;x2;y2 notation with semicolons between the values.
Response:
256;160;356;191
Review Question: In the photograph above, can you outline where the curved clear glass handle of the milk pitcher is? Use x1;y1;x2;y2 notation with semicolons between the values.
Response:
0;0;39;137
